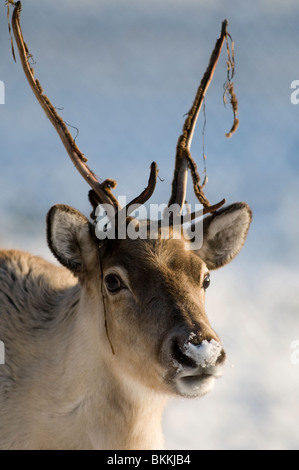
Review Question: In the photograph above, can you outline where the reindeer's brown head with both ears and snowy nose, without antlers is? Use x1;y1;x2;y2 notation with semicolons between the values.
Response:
48;203;251;396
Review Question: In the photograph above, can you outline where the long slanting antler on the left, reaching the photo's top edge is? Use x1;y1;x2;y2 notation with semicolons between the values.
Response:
12;2;117;207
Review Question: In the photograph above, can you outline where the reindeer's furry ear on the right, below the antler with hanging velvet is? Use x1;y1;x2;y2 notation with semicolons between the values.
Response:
196;202;252;269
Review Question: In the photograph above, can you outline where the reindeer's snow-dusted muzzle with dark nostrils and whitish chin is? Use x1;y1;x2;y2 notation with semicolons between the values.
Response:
164;334;225;397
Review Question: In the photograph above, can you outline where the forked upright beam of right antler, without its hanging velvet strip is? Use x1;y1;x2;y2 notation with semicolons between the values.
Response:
168;20;228;214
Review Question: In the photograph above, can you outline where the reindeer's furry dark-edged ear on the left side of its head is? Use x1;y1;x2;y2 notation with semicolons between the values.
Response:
47;204;97;275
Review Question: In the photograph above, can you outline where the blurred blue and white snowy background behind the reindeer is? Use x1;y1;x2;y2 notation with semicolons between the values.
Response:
0;0;299;449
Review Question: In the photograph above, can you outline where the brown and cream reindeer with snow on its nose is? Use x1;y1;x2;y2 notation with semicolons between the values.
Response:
0;2;251;450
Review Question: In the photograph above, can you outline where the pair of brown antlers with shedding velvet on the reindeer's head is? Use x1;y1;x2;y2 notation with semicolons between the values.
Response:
10;0;238;229
